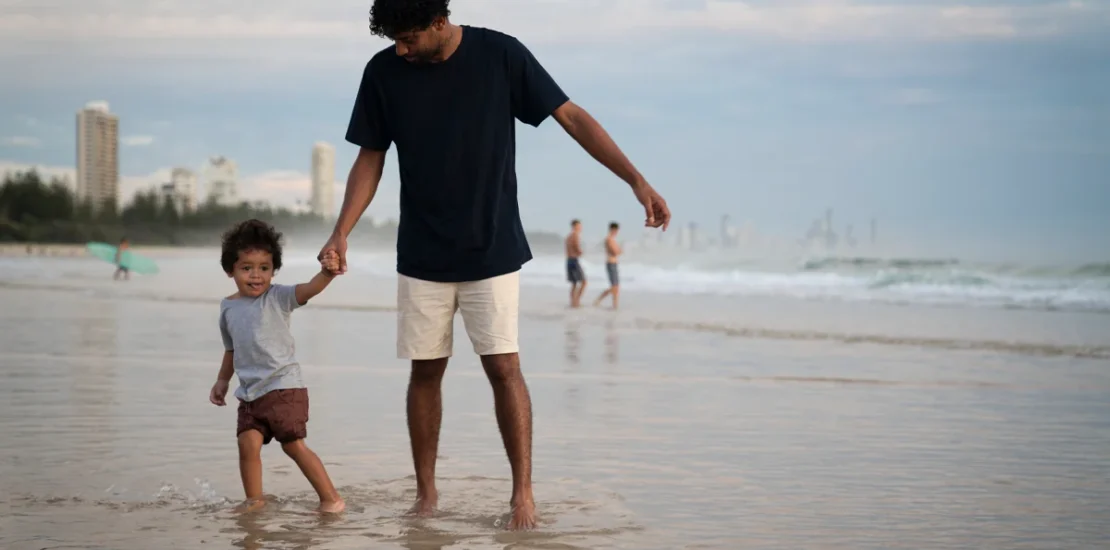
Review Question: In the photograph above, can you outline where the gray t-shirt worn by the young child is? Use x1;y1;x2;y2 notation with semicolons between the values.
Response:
220;284;304;401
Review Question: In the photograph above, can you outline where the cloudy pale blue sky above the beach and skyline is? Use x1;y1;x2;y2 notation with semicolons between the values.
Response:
0;0;1110;261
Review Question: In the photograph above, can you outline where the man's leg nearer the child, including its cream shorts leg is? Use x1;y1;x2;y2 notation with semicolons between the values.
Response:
397;276;458;516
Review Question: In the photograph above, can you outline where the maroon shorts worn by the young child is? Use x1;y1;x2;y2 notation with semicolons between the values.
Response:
235;388;309;444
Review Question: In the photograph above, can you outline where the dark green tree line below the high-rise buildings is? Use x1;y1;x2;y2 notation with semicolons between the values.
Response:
0;170;330;244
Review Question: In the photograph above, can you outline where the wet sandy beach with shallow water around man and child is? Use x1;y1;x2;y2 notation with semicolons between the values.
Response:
0;251;1110;550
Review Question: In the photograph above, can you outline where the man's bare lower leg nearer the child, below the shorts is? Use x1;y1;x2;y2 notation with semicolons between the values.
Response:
405;358;447;516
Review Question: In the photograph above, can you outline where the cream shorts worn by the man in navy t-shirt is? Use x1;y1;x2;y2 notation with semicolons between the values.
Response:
397;271;521;360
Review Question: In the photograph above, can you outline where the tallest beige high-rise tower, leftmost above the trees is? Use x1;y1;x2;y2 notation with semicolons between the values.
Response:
77;101;120;211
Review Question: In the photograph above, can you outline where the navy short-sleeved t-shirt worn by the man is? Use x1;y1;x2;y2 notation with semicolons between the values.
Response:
346;27;567;282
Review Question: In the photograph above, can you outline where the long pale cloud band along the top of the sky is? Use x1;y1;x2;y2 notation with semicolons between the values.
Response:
0;0;1110;56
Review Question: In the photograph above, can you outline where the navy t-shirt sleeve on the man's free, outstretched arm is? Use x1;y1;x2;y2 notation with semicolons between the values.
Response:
508;38;569;127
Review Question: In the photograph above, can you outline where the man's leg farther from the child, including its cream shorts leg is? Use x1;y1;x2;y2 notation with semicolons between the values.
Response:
458;272;536;530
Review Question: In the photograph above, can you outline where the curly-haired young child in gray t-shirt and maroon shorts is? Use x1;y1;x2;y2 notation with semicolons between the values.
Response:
209;220;346;513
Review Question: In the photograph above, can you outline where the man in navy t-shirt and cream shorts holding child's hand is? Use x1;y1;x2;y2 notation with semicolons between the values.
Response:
321;0;670;529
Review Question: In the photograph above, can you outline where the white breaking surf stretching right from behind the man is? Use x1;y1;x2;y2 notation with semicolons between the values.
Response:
522;258;1110;313
